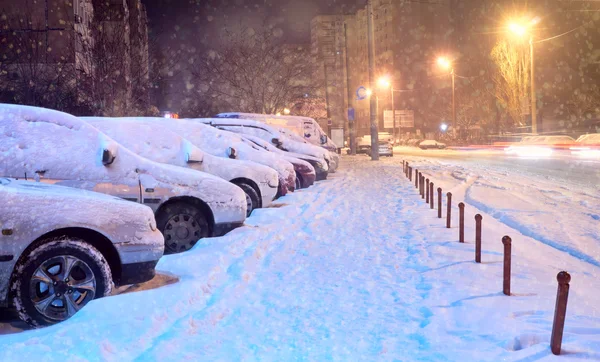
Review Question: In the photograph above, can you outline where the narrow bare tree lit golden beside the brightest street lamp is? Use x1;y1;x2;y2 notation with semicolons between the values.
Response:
491;40;531;130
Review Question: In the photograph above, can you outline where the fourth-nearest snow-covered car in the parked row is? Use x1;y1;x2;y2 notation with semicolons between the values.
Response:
144;118;296;197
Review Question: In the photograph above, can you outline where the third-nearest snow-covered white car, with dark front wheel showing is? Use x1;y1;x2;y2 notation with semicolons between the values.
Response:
82;117;279;216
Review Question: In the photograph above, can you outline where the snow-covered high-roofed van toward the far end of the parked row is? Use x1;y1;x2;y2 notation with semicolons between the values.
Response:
216;112;338;152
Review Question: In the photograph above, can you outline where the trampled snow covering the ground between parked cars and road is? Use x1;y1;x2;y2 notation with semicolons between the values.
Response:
0;154;600;361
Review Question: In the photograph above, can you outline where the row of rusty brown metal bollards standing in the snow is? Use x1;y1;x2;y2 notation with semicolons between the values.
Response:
402;161;571;355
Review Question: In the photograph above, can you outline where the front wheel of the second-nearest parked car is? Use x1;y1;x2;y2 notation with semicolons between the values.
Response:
156;202;209;254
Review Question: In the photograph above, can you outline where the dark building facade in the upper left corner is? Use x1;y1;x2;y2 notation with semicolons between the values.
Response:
0;0;149;115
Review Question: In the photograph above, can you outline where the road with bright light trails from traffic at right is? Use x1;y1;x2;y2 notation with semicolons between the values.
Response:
394;147;600;188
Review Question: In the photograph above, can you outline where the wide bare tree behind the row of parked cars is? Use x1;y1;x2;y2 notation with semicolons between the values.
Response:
191;25;318;113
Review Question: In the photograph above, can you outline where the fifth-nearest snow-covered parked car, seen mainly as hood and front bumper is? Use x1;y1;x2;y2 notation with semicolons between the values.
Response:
242;135;327;189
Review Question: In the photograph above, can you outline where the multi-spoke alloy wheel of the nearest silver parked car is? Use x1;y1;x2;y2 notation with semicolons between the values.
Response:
11;237;113;327
